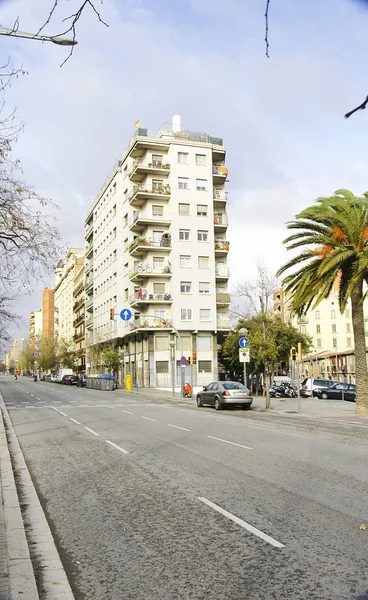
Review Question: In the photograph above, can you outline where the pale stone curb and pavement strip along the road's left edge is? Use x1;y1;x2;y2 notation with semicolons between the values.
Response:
0;393;74;600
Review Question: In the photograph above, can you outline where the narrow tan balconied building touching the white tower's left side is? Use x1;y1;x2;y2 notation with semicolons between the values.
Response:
73;263;86;373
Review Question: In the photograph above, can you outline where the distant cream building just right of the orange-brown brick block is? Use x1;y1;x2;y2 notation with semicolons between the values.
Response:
54;248;84;343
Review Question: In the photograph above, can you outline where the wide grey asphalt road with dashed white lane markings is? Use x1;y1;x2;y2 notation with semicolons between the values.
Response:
0;377;368;600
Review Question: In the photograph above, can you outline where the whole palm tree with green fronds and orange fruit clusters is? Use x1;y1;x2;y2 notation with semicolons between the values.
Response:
277;190;368;414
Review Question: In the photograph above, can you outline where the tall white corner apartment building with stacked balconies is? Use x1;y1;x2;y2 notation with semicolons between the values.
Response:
85;116;231;387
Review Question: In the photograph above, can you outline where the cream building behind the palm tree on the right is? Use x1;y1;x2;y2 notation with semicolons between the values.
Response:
274;284;368;380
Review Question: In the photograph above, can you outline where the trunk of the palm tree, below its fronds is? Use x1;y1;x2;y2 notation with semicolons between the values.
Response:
351;284;368;415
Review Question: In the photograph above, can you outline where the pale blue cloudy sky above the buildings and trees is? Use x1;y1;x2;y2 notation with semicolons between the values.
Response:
0;0;368;346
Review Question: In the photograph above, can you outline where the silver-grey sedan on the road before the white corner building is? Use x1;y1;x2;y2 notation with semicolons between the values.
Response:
197;381;253;410
